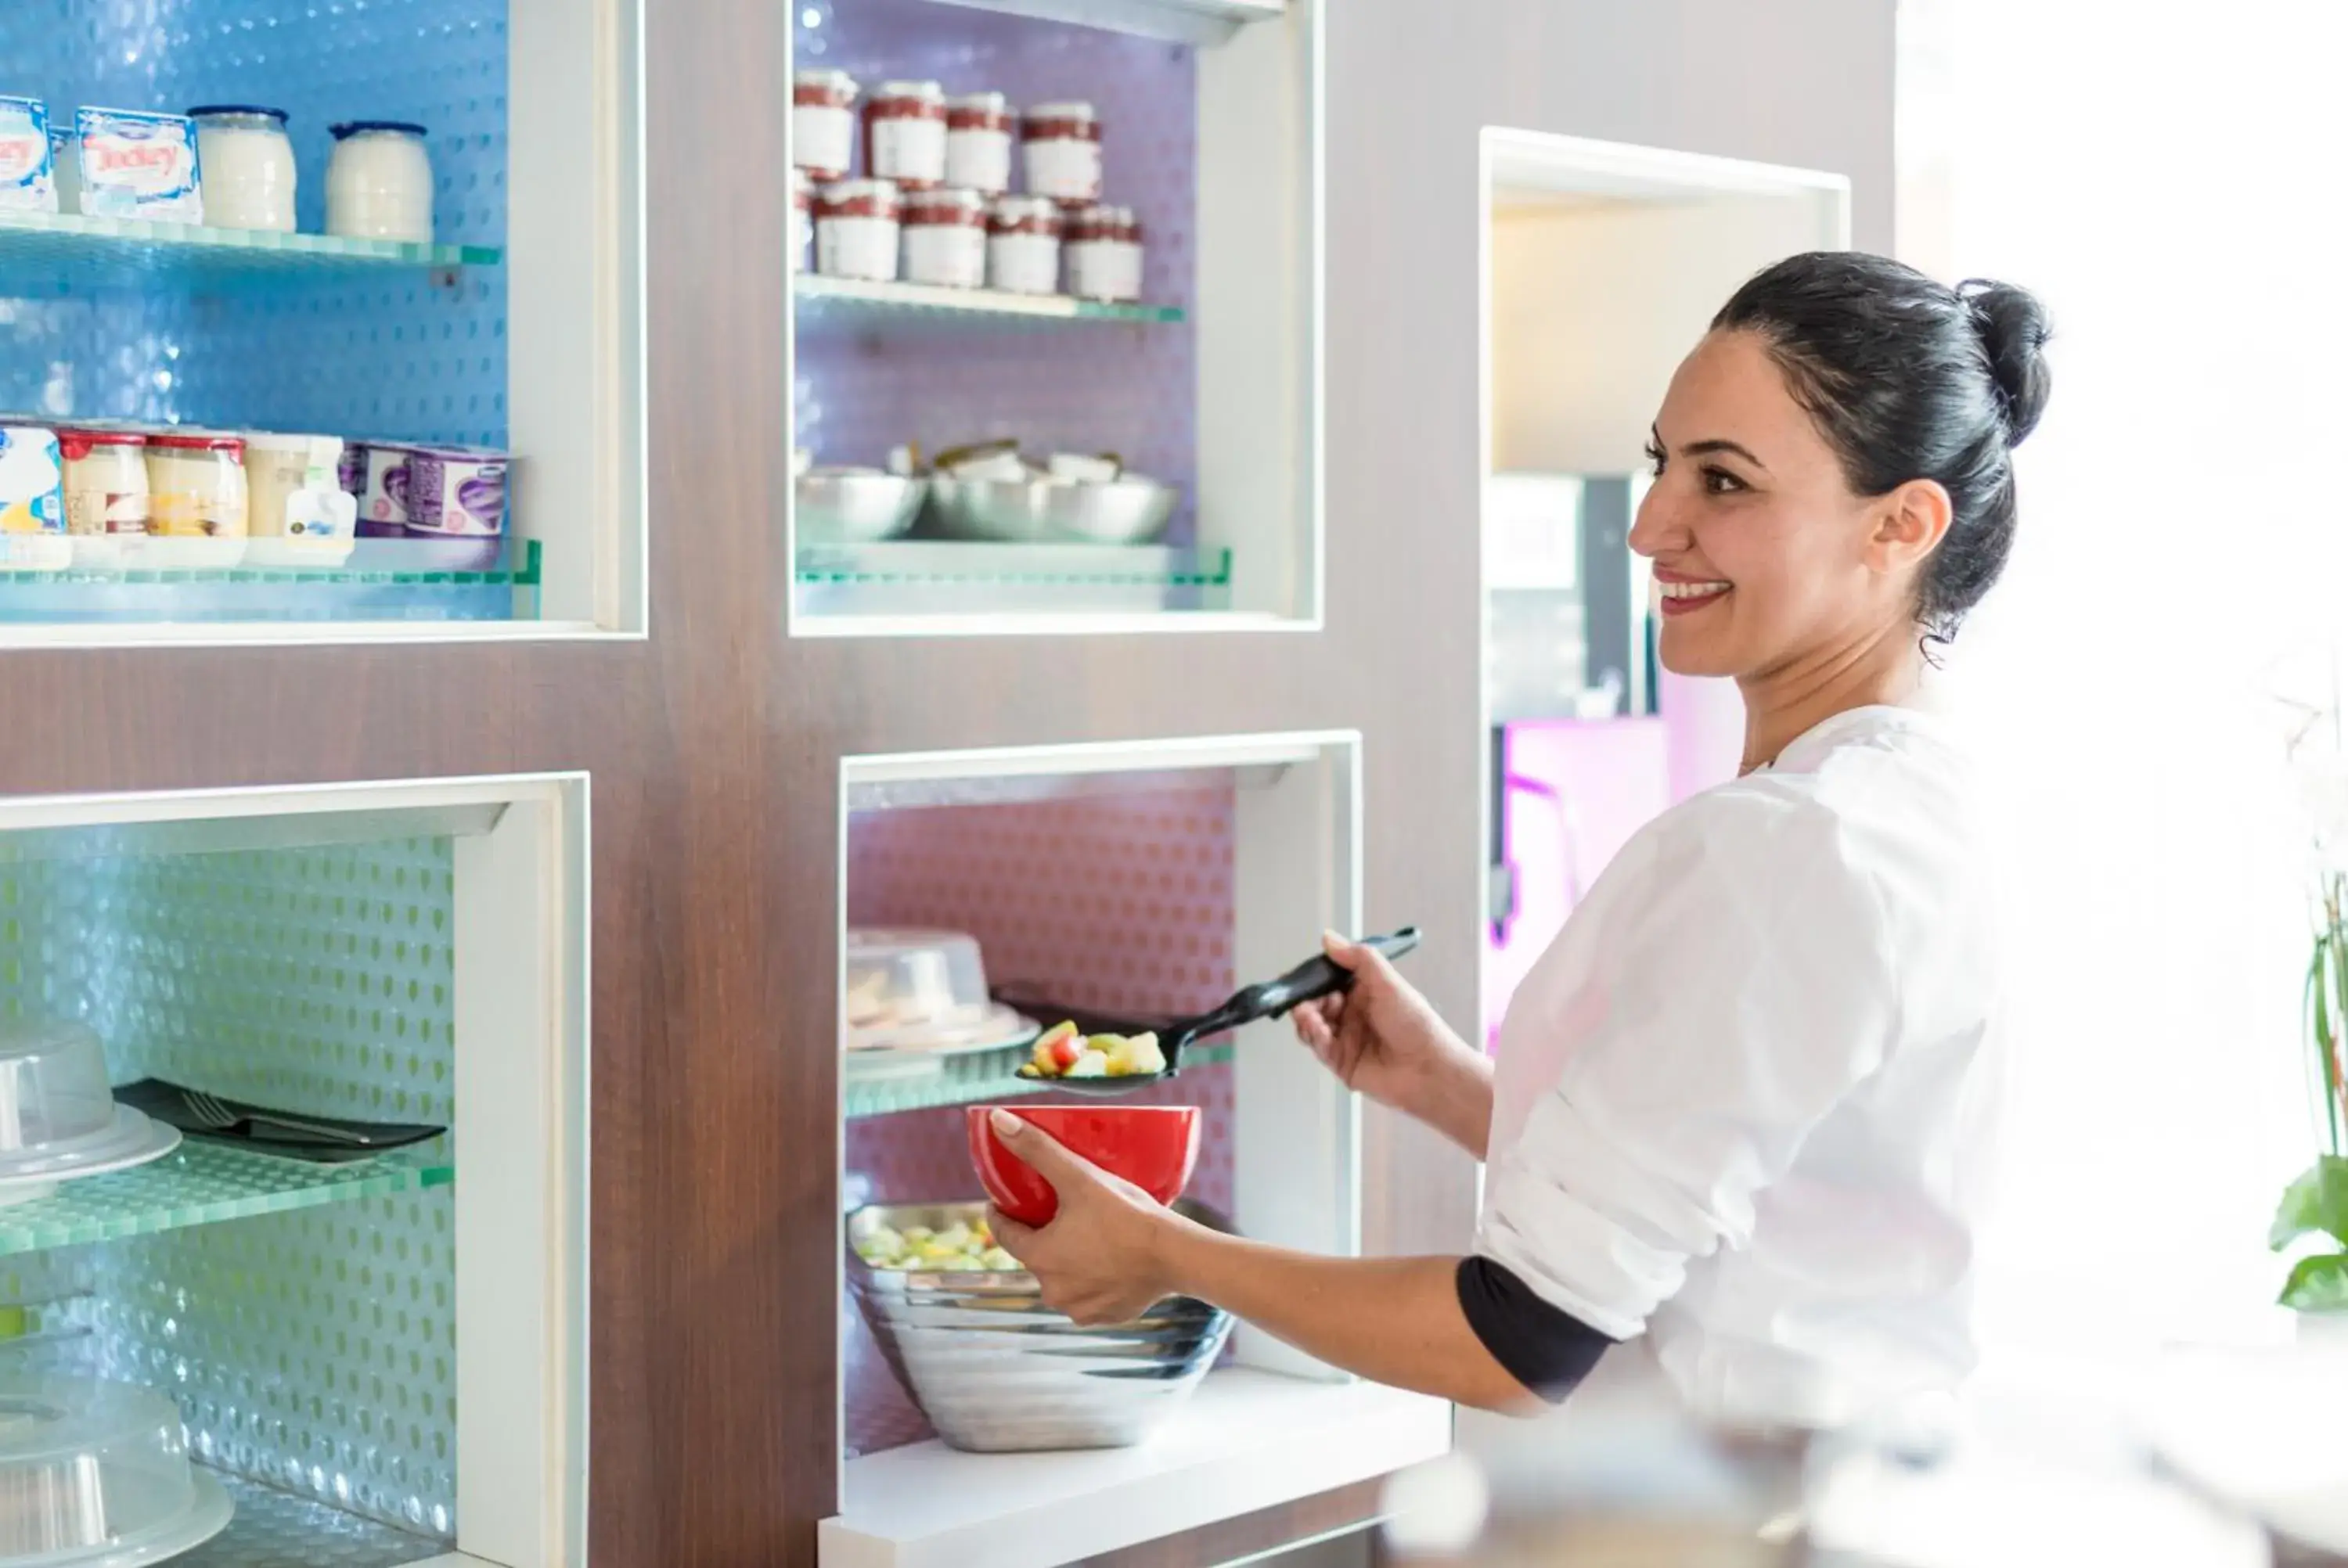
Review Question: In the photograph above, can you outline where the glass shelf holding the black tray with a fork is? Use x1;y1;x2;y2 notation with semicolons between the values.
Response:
0;1138;456;1256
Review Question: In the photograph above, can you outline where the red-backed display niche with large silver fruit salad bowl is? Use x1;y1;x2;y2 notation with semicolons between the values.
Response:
819;735;1451;1568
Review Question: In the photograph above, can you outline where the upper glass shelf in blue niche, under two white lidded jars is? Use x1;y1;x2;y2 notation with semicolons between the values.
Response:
0;211;505;291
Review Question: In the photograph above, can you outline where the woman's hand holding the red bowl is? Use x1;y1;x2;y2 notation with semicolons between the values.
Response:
986;1110;1186;1326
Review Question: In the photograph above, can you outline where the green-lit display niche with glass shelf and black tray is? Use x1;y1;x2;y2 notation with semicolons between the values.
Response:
0;777;587;1568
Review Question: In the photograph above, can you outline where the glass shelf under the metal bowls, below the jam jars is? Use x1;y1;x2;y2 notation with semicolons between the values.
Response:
798;540;1230;615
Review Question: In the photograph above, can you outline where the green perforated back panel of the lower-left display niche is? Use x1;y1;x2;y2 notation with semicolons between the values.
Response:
0;840;456;1537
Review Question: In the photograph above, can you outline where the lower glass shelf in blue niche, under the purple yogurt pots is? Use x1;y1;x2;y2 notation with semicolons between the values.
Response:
0;540;545;624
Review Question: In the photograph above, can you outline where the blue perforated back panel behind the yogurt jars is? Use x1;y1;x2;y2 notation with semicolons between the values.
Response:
0;0;507;446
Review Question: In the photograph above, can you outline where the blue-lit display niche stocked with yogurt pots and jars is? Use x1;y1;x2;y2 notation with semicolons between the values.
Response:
0;0;646;646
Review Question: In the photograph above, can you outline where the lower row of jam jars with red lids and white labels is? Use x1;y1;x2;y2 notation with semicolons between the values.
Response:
798;181;1141;303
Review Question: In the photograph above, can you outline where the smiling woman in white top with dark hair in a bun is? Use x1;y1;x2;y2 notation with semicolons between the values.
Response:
996;254;2047;1427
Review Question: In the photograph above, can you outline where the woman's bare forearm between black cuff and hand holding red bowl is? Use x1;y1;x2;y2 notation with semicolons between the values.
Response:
1165;1225;1538;1411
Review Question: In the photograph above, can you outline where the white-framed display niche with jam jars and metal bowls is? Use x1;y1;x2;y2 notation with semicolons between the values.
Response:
787;0;1322;636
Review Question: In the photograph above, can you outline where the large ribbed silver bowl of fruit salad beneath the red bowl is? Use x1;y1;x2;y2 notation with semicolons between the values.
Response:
848;1202;1230;1453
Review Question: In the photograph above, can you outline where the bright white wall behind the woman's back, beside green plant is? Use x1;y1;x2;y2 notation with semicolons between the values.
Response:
1902;0;2348;1340
